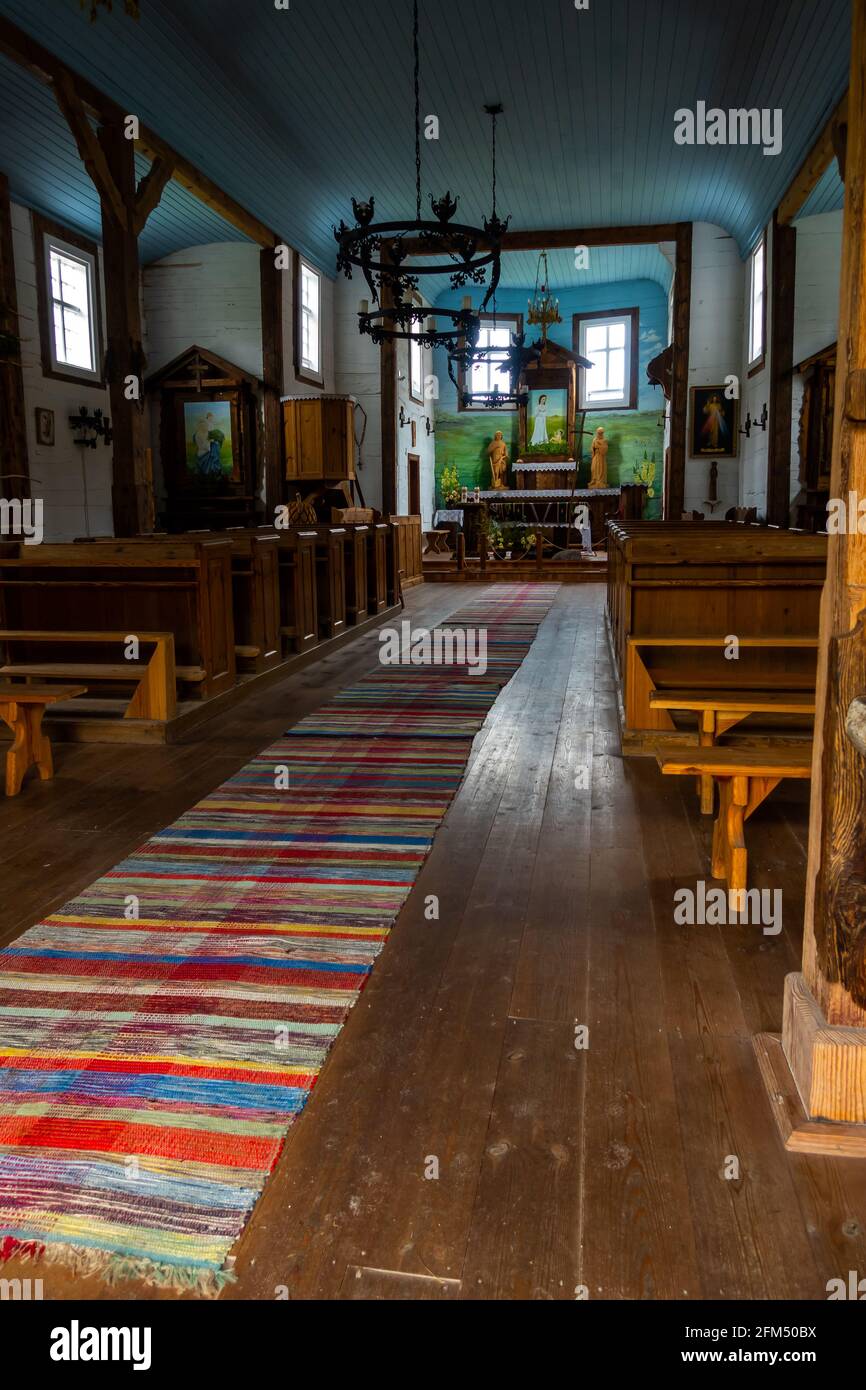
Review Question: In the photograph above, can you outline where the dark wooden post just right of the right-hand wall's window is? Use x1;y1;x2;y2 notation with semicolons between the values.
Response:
767;213;796;527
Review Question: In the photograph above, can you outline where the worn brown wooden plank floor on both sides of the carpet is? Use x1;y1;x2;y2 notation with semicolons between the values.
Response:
0;584;866;1300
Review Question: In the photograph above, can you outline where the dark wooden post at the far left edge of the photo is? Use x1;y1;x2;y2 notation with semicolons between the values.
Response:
0;174;31;499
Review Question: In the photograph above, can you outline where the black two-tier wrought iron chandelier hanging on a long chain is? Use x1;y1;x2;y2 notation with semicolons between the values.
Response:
334;0;510;353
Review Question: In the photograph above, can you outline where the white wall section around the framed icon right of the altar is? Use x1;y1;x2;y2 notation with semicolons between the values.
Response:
685;222;745;517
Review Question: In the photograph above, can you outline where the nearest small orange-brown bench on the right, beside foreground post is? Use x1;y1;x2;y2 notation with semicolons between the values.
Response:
657;745;812;891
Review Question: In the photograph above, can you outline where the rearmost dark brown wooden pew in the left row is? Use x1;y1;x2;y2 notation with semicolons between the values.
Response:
0;537;235;699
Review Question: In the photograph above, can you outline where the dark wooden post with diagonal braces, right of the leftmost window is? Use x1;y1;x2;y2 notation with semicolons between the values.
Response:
97;121;153;535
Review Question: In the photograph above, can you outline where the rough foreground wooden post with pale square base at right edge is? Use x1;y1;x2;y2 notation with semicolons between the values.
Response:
756;0;866;1155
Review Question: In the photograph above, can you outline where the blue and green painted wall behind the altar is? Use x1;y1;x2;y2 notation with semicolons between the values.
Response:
434;279;667;517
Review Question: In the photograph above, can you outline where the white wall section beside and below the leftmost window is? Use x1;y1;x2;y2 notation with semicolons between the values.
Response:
11;203;114;541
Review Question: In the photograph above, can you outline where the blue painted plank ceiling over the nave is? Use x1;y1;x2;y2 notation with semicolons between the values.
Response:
0;0;849;269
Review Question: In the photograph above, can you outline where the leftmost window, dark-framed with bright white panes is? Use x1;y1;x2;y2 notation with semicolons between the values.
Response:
33;214;103;385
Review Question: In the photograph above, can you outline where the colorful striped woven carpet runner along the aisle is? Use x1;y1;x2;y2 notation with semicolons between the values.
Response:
0;585;556;1293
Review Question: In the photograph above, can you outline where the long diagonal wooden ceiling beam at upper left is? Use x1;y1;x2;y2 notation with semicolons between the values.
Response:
0;17;284;246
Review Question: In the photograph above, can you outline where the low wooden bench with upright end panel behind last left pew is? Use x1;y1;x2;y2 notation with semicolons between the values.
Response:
0;628;179;720
